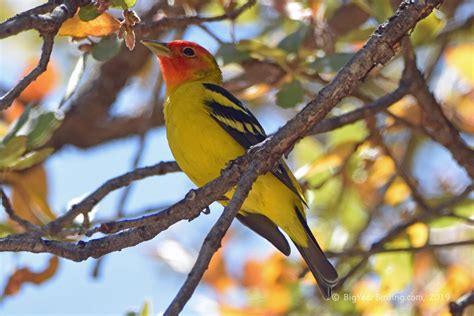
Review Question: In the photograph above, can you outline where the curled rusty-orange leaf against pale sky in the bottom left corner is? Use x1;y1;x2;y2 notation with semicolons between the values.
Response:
3;256;59;296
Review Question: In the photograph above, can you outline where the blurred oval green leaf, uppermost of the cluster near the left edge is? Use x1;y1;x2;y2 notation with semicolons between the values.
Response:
27;112;64;149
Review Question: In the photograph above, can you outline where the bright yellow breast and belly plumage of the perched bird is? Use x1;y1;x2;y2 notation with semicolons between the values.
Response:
165;83;306;245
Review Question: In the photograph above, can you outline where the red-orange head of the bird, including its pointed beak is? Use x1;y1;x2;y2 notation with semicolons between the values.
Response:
142;40;222;94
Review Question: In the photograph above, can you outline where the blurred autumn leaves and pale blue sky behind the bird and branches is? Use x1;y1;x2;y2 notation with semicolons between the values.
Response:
0;0;474;315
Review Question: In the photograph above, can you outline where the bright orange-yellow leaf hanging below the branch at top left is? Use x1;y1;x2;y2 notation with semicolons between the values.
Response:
58;13;120;38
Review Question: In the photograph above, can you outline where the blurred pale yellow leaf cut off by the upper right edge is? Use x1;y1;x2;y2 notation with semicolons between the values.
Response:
444;43;474;85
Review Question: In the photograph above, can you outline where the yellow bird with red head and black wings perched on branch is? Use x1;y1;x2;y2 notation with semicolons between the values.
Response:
141;40;338;299
